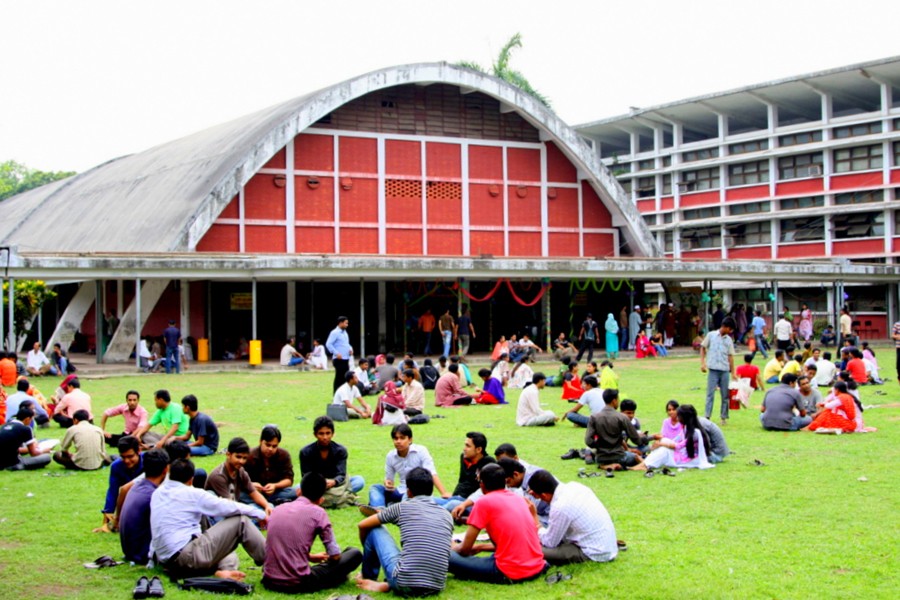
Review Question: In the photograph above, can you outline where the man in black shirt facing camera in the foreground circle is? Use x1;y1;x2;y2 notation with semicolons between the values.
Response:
300;417;366;508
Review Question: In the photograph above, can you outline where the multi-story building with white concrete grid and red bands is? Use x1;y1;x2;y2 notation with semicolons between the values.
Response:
576;57;900;337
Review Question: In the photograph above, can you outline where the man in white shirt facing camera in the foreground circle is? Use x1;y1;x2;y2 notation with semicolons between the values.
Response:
361;424;455;508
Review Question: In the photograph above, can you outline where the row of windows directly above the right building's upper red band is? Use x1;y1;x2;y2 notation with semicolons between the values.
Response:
622;142;900;193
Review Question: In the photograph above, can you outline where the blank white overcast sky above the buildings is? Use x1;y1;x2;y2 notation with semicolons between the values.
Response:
0;0;900;171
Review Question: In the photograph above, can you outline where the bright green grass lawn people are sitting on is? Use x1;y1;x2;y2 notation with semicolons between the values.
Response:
0;347;900;600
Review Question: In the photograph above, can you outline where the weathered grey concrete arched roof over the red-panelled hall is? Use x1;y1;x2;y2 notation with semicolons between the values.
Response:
0;63;660;257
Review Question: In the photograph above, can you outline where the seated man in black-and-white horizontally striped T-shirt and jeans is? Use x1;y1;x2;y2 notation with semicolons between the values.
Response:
357;467;453;596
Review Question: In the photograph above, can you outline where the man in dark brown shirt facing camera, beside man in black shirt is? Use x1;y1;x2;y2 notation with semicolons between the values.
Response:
240;425;297;506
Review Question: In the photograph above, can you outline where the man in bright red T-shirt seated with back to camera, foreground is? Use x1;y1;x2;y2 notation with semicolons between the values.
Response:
450;464;549;583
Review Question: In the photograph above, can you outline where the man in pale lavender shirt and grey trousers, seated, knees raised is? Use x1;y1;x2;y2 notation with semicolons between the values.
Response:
150;460;268;581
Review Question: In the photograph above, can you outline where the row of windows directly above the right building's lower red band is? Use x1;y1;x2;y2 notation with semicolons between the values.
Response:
662;211;900;252
